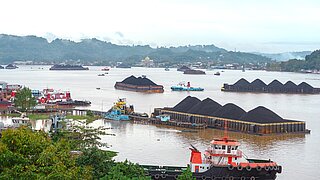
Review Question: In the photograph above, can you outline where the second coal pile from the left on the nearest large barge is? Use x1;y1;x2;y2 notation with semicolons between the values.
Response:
188;98;222;116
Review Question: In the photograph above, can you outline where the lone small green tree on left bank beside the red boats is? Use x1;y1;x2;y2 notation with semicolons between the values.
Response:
14;87;37;111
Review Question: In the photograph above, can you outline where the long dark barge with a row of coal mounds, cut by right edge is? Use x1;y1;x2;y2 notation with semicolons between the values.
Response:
221;78;320;94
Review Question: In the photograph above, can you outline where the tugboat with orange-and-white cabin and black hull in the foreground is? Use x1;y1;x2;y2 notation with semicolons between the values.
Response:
142;137;282;180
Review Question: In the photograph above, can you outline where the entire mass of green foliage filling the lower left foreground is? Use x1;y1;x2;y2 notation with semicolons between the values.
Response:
0;121;150;180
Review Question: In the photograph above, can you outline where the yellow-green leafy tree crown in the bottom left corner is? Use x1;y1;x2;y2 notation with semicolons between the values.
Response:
0;127;91;179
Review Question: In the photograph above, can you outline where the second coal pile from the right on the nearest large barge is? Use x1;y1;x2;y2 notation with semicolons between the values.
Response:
213;103;246;119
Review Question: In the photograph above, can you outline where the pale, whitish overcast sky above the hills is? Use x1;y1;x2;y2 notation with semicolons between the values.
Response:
0;0;320;53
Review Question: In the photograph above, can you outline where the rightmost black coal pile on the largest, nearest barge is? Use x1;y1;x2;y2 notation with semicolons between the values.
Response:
240;106;285;123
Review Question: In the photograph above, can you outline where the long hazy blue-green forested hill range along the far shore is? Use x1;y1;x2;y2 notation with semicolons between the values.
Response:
0;34;270;64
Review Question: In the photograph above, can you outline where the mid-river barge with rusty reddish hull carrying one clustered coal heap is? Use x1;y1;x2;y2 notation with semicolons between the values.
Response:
114;76;164;93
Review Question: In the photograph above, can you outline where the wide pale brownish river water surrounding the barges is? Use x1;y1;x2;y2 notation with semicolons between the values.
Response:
0;66;320;179
